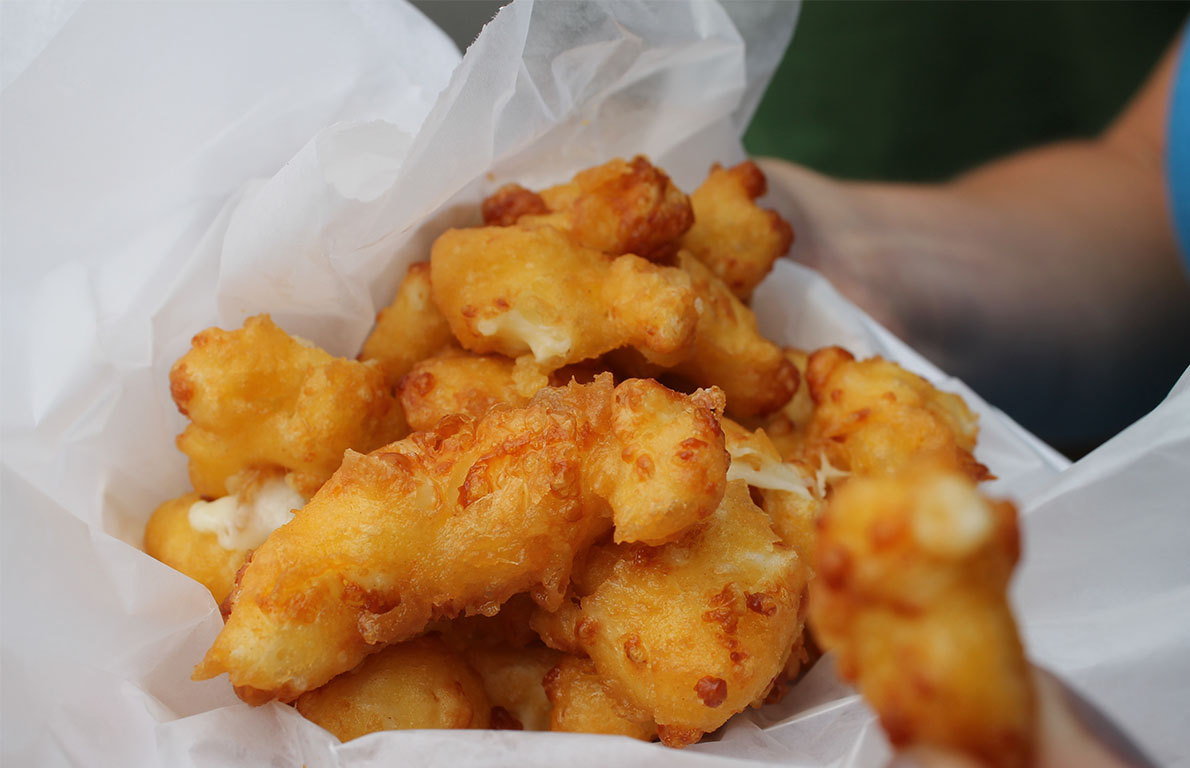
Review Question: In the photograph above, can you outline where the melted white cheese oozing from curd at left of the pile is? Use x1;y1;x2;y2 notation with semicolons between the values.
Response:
190;475;306;550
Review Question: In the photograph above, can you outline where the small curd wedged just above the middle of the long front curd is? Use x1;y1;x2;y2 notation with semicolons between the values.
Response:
396;351;528;431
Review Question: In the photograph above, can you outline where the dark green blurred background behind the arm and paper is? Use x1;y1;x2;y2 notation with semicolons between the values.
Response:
414;0;1190;457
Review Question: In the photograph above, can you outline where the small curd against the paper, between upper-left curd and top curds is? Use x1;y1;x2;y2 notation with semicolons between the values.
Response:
359;262;455;385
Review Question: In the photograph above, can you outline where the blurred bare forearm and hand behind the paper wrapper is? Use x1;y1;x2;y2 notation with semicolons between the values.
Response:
760;43;1190;438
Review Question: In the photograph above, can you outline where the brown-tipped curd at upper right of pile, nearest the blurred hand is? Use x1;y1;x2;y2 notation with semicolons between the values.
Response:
682;161;794;301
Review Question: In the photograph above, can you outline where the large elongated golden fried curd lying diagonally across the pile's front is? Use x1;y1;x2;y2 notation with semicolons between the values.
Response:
194;375;727;704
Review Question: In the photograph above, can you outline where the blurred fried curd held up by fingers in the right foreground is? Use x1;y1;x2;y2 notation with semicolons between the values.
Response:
810;469;1035;768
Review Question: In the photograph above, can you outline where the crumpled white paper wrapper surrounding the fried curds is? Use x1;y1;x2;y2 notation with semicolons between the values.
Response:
0;0;1190;768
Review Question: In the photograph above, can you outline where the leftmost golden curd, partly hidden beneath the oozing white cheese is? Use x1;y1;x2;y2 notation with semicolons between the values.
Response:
144;493;248;602
